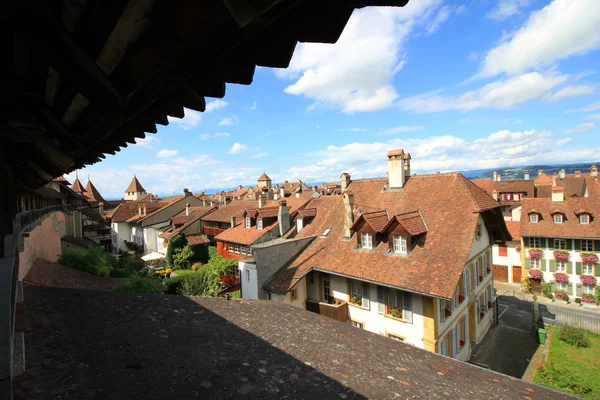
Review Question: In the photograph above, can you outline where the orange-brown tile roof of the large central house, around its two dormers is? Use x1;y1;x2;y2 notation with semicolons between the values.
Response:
266;174;503;298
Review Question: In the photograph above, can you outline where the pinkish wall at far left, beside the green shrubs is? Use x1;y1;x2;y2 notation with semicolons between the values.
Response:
19;212;66;280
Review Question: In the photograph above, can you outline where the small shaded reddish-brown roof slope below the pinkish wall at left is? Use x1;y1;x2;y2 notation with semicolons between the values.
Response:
23;258;120;291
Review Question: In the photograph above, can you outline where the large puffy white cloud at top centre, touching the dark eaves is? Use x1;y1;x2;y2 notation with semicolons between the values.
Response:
277;0;444;113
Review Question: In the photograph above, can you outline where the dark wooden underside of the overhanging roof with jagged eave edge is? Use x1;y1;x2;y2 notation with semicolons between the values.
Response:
0;0;408;188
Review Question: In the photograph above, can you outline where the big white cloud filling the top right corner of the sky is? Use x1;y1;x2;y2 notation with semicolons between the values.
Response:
478;0;600;77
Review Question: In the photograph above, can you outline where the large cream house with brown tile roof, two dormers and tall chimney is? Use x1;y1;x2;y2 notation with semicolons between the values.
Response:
240;150;510;360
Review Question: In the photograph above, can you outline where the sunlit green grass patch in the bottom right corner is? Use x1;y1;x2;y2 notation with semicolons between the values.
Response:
533;326;600;399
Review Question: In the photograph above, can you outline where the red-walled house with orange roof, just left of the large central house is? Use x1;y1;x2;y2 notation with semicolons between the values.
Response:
215;197;309;260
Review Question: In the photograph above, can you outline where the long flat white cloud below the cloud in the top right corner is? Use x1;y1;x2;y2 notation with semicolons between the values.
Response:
398;72;569;112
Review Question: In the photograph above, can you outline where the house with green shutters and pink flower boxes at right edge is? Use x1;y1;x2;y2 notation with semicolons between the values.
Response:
520;176;600;297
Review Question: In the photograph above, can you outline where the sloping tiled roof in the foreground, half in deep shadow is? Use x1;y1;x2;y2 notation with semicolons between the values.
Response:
15;286;568;400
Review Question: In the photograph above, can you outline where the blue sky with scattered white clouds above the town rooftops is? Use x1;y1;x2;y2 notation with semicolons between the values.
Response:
67;0;600;198
